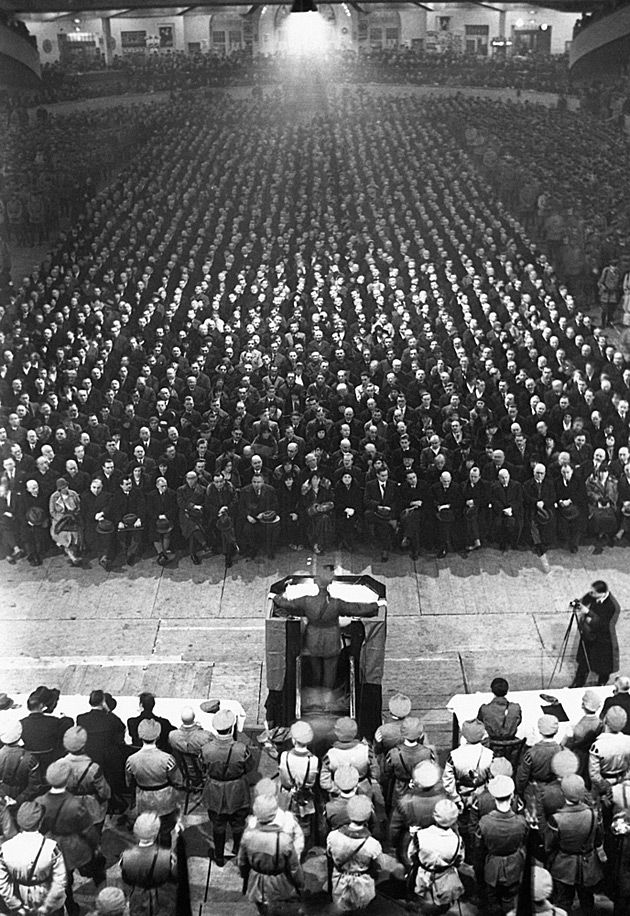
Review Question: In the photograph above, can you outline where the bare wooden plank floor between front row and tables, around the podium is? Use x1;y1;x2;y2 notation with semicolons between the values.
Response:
0;547;630;748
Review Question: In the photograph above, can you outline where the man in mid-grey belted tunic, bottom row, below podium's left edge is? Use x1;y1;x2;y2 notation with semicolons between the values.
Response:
237;795;304;916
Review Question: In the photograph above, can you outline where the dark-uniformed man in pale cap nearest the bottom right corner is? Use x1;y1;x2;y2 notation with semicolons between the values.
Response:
545;775;603;916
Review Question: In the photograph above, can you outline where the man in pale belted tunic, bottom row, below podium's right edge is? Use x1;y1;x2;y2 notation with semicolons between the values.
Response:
326;795;382;912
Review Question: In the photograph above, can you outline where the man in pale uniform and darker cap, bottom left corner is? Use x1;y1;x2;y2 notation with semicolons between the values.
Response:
0;801;66;916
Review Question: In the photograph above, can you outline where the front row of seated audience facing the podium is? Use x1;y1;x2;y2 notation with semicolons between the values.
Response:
0;435;630;569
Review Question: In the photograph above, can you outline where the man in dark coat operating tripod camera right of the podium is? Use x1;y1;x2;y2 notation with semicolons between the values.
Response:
571;579;618;687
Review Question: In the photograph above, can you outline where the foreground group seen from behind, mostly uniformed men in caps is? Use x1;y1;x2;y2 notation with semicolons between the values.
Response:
0;677;630;916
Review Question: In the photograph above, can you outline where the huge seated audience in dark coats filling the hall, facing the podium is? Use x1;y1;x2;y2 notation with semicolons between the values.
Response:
0;94;630;568
